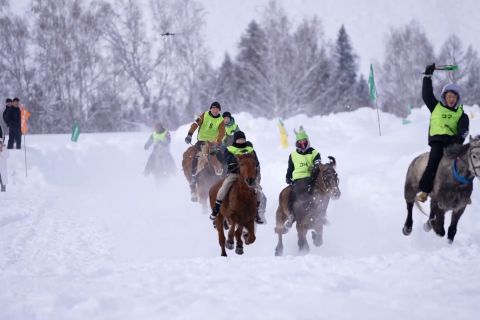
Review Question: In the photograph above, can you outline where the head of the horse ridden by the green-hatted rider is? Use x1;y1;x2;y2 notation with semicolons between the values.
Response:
312;156;341;200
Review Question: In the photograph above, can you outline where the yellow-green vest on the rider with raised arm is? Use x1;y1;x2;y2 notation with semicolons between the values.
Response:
429;102;463;136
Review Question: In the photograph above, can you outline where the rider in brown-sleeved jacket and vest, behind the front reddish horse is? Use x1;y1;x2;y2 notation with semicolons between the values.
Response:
185;101;225;199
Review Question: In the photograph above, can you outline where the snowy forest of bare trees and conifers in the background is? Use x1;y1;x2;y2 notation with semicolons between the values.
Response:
0;0;480;133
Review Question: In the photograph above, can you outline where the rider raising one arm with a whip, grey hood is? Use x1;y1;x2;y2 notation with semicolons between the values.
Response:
417;64;469;202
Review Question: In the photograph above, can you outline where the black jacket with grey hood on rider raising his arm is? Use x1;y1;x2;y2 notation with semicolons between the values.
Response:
422;77;470;145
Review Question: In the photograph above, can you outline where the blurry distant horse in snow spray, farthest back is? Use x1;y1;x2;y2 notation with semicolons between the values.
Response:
144;143;176;183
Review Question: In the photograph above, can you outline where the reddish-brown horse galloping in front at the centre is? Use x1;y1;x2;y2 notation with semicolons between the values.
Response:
210;154;257;257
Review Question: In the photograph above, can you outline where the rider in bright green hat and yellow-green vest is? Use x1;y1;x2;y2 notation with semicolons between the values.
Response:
285;126;321;228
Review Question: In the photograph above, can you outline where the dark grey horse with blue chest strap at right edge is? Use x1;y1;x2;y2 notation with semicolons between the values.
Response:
402;136;480;243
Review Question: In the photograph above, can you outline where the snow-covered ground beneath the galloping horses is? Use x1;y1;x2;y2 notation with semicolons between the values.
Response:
0;107;480;320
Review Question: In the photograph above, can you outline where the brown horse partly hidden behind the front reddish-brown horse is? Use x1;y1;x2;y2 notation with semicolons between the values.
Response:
182;142;223;210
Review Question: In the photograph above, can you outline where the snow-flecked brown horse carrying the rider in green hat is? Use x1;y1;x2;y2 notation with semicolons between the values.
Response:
275;156;341;256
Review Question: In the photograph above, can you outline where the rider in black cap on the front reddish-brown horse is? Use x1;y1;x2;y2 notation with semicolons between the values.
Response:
210;131;267;224
